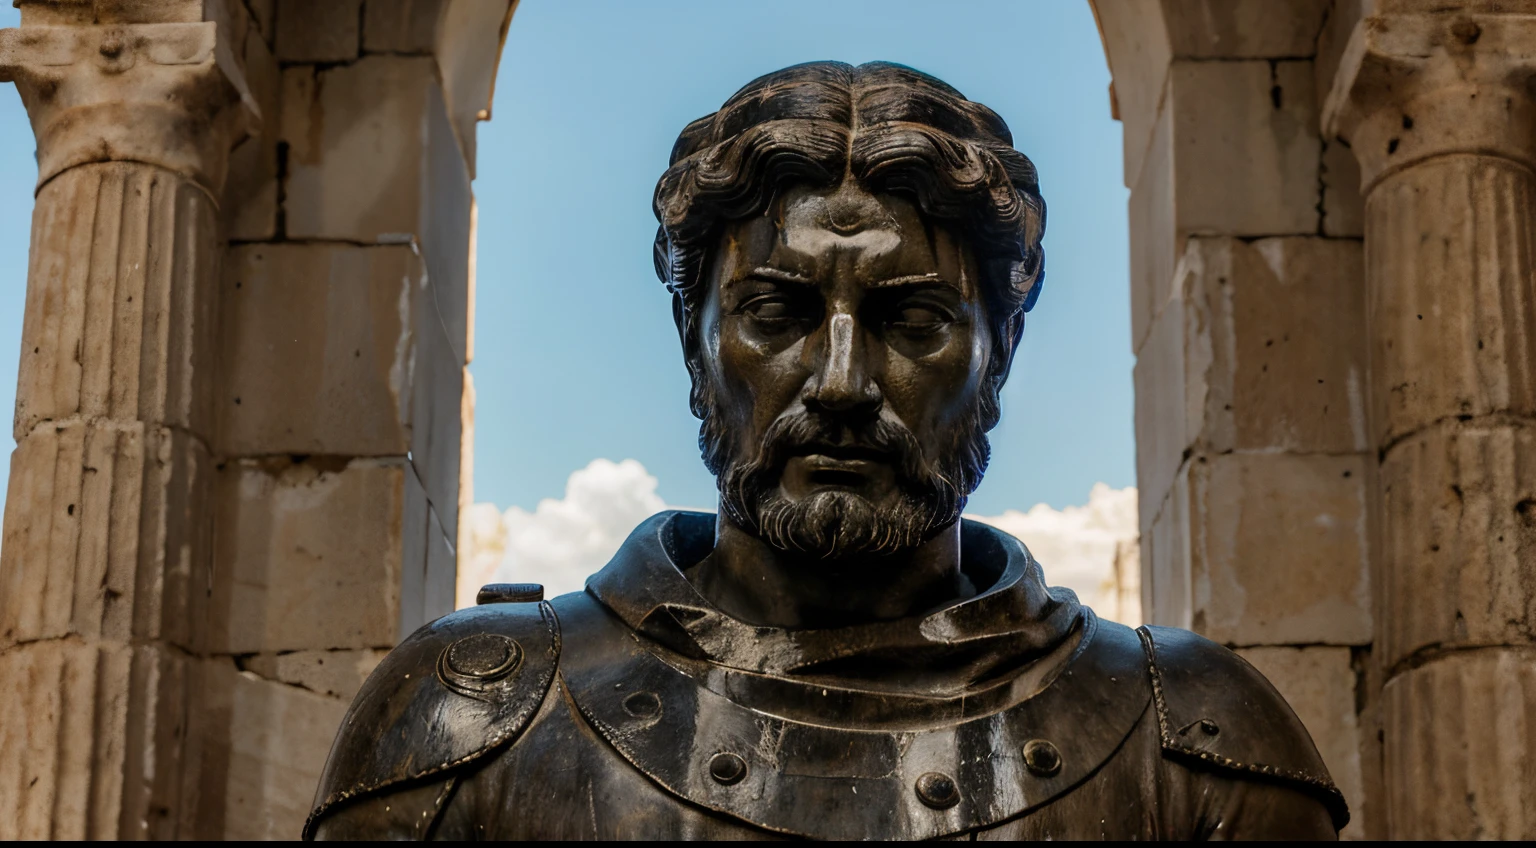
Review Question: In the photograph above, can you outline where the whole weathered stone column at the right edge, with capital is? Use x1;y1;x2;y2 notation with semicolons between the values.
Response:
1322;8;1536;839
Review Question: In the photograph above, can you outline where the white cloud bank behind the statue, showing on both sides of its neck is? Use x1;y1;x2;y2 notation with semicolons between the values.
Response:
458;459;1141;625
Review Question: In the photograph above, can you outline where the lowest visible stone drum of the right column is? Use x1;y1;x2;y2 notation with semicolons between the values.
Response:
1382;648;1536;840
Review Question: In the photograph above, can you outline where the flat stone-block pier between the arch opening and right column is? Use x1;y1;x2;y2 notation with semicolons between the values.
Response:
1094;0;1379;836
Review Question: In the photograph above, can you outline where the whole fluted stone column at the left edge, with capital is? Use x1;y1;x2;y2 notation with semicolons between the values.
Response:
0;3;257;840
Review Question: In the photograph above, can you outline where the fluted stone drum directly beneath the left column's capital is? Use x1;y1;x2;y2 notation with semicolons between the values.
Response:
12;163;218;441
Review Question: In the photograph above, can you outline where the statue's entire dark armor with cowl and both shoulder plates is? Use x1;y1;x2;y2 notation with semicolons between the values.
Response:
304;515;1347;839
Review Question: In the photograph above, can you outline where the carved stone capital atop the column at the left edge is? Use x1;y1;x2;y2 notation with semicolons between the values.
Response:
0;22;260;198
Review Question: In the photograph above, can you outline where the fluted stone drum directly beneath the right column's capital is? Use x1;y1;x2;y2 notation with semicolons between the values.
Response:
1366;155;1536;444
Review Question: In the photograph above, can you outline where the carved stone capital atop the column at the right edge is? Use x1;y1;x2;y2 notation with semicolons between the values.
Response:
1322;11;1536;192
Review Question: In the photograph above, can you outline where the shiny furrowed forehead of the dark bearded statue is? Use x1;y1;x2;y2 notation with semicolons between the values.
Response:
728;180;969;281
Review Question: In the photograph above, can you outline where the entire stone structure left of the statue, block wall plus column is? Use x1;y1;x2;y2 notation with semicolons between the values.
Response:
0;0;513;839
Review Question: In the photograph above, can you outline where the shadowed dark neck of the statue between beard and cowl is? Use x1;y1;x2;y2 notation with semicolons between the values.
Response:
687;512;975;628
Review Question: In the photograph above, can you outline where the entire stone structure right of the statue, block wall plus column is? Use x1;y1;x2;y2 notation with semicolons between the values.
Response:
1094;0;1536;839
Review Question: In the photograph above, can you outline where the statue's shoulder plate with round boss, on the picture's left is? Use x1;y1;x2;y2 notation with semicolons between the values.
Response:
304;602;561;839
